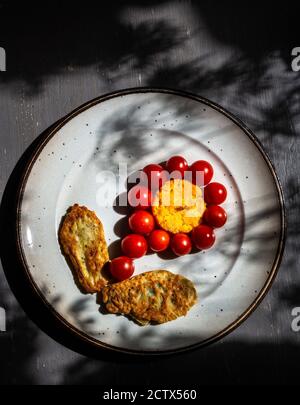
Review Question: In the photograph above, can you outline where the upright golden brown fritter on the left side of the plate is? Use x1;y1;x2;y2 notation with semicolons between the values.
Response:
59;204;109;293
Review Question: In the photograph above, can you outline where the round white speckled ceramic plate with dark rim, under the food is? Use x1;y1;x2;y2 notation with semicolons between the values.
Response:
18;89;284;354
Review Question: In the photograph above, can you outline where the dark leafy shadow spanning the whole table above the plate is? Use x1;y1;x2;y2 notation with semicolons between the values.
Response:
0;0;300;142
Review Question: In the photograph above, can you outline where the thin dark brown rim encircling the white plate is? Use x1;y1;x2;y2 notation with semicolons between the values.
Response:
16;87;286;355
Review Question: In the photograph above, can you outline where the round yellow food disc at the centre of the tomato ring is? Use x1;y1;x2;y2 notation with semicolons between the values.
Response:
152;179;205;234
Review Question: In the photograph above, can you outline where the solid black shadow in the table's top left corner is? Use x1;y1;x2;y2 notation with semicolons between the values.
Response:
0;0;178;95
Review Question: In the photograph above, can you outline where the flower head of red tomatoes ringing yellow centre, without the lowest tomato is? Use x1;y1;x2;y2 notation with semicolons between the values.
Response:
122;156;227;258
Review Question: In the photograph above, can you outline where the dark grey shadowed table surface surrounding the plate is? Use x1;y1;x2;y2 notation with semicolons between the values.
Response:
0;1;300;386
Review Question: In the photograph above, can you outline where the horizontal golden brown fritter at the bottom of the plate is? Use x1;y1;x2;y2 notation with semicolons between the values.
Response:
102;270;197;325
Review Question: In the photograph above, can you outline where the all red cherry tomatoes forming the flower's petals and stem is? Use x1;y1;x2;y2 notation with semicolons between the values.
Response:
110;156;227;281
